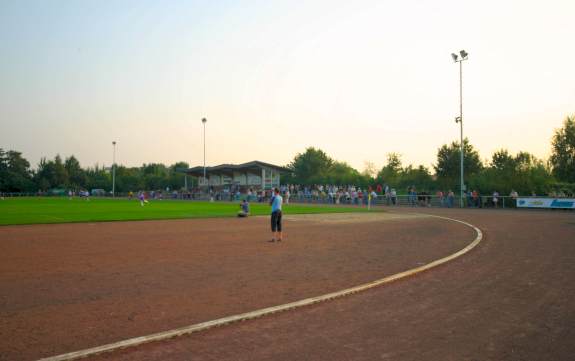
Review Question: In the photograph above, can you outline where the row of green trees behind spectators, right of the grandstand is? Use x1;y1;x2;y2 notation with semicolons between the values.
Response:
284;116;575;195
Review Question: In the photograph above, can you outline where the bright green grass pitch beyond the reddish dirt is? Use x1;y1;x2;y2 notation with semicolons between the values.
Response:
0;197;378;225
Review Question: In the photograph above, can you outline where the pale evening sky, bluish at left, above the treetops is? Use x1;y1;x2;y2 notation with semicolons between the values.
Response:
0;0;575;170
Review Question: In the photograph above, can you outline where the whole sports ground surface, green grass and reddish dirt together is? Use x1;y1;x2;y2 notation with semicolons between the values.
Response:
0;198;575;361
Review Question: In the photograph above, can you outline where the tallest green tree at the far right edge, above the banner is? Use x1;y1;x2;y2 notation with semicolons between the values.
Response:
549;116;575;183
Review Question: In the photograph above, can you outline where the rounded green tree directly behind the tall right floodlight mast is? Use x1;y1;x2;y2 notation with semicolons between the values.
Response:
433;138;483;190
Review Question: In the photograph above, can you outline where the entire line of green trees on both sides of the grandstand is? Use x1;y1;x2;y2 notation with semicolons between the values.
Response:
0;116;575;195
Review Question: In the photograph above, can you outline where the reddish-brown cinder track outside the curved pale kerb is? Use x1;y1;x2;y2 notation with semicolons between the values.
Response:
86;210;575;361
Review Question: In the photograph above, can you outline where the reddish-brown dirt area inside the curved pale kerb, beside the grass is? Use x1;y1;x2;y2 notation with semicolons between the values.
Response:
0;213;474;360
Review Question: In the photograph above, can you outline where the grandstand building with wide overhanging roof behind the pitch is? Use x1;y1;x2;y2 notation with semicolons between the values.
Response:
185;160;290;190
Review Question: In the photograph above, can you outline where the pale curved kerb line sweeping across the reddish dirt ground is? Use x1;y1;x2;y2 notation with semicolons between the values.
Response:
38;215;483;361
